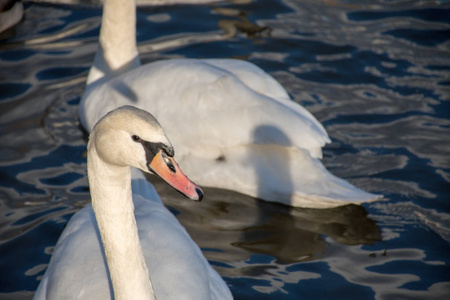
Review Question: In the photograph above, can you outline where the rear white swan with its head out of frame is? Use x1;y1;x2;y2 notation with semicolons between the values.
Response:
80;0;378;208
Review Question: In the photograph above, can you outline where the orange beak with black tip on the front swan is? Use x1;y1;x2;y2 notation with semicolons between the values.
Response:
148;150;203;201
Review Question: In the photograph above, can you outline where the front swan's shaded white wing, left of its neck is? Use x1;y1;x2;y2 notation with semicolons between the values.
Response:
33;205;111;300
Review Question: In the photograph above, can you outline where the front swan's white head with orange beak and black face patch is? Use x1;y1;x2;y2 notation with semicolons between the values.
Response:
88;106;203;201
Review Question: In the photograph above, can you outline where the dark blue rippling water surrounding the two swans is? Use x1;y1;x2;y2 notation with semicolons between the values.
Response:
0;0;450;299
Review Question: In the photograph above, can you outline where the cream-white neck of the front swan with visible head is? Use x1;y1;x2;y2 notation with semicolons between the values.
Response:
88;145;156;300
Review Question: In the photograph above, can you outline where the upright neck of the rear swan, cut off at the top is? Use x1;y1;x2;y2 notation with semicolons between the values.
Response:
87;0;140;84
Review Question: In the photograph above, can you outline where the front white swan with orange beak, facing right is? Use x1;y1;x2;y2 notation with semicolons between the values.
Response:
34;106;232;300
